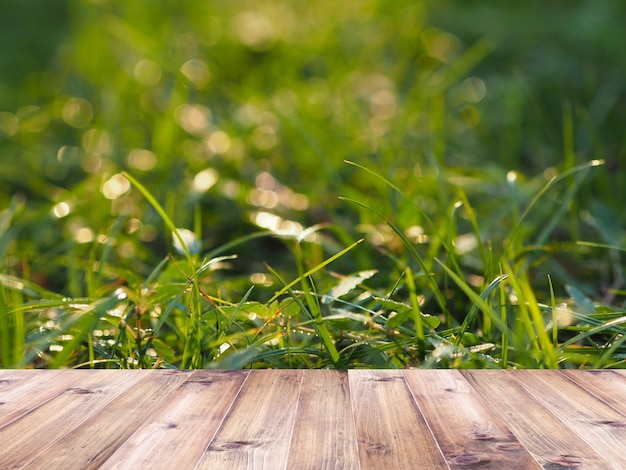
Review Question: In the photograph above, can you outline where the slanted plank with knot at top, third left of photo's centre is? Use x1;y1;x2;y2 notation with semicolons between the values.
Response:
101;370;249;469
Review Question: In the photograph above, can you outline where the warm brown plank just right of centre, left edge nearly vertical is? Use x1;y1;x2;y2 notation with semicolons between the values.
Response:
348;370;448;470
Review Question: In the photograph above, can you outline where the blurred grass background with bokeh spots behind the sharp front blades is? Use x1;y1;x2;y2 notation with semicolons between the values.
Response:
0;0;626;368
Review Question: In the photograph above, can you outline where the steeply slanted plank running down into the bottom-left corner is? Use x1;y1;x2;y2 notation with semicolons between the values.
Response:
0;370;148;468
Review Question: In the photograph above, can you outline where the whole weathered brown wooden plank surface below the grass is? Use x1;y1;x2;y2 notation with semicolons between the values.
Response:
0;370;626;470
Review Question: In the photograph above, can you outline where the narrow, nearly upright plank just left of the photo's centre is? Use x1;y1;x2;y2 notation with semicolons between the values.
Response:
287;370;359;470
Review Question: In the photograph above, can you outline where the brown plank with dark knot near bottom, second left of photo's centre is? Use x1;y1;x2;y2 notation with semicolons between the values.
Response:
197;370;302;470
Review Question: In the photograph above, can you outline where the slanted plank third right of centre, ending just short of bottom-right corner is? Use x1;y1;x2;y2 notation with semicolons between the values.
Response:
461;370;611;469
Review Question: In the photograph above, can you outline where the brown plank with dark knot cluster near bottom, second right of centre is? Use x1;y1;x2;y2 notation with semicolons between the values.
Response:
404;370;541;470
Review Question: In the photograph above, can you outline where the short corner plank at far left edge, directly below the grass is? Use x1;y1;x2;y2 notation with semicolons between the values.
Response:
0;370;86;428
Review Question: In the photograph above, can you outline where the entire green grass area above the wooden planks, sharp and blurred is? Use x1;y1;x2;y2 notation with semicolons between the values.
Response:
0;0;626;367
